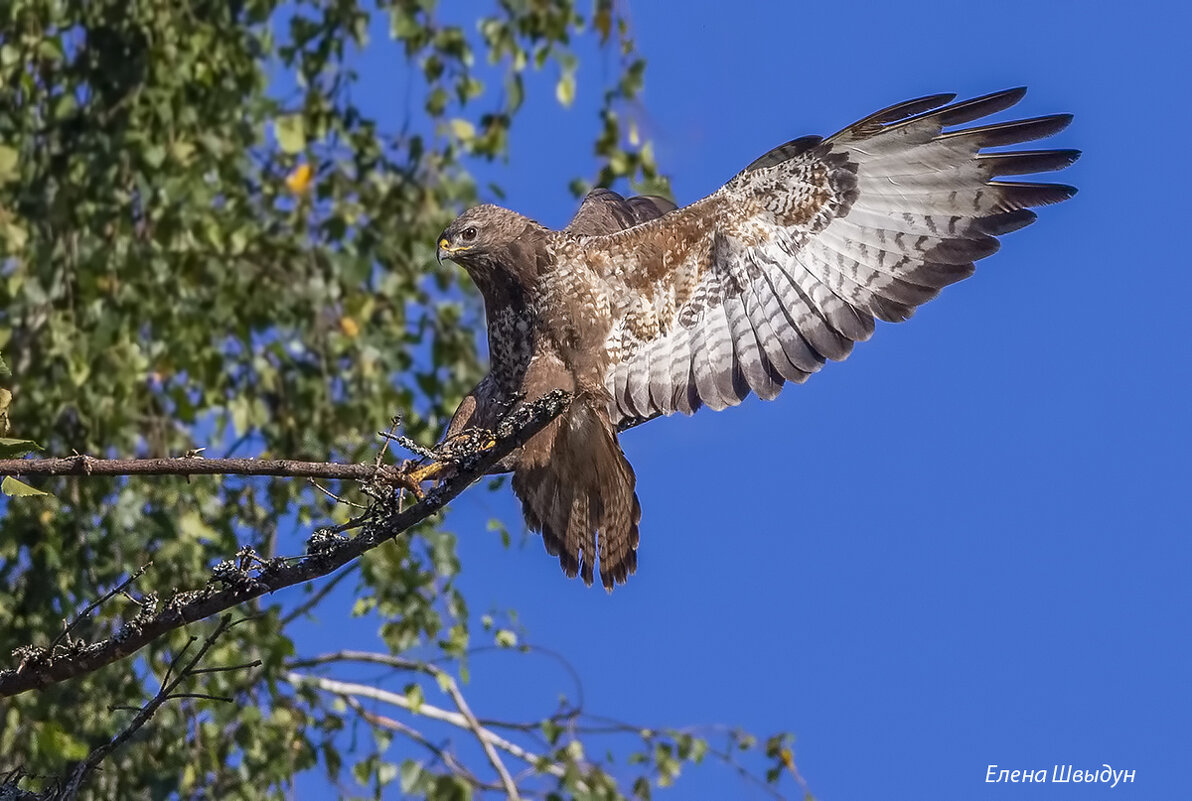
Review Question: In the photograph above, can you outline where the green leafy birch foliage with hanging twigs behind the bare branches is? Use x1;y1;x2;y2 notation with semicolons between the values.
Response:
0;0;793;799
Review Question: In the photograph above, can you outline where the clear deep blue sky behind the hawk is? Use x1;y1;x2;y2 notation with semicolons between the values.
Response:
293;0;1192;801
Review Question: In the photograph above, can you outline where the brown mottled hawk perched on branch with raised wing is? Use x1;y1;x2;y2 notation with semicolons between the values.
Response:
437;88;1080;590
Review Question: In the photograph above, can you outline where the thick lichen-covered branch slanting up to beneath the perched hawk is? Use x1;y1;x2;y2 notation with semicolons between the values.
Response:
0;391;570;697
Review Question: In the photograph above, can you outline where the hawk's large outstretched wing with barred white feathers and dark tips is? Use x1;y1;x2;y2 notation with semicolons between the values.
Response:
596;89;1080;428
